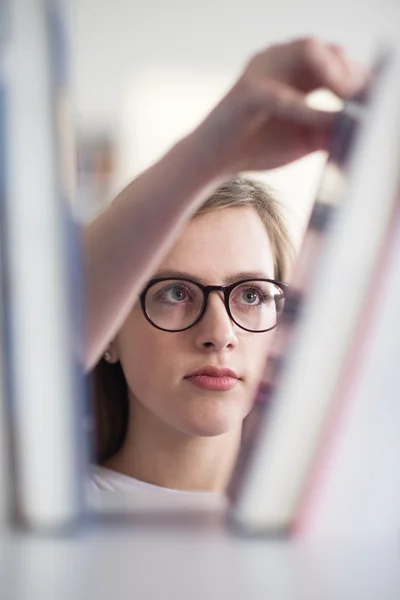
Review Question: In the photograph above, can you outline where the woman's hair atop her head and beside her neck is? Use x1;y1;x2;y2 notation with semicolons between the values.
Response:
93;177;294;463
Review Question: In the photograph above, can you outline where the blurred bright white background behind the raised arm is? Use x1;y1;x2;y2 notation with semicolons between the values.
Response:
64;0;400;240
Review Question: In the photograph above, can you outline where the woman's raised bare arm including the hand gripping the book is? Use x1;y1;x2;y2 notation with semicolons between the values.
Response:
84;40;366;368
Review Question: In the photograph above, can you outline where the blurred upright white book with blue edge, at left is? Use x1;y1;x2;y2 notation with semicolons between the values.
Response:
6;0;85;530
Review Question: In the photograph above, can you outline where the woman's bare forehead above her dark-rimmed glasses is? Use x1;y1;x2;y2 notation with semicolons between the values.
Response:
159;207;274;283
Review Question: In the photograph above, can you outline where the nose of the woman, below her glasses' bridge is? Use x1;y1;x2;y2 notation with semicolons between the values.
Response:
193;292;238;352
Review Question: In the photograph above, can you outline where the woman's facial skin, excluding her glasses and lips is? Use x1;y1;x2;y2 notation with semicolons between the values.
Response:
115;207;274;436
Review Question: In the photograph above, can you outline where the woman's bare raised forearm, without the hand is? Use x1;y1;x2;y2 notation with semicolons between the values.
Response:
84;135;223;368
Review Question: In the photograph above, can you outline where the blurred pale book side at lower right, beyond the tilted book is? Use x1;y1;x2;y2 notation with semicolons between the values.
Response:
299;209;400;547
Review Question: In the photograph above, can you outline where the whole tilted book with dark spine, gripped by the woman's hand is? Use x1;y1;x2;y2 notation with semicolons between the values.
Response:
229;49;400;533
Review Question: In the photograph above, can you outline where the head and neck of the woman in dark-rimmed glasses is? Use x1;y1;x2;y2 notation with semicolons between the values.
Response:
94;178;291;492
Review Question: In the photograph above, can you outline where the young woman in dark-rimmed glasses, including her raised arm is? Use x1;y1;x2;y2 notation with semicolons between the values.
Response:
85;39;366;492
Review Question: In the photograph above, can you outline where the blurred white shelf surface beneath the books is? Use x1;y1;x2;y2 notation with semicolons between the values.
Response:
0;515;400;600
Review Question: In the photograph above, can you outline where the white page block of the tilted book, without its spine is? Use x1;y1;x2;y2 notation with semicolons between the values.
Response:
230;50;400;533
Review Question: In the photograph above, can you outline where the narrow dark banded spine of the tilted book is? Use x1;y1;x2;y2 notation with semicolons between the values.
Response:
228;105;357;504
